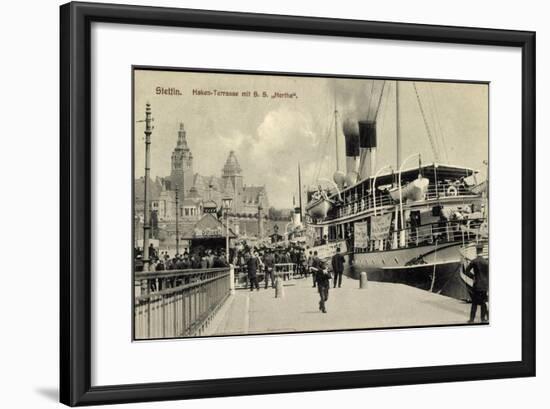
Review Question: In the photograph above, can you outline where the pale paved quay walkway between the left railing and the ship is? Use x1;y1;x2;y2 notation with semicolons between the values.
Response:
212;277;470;335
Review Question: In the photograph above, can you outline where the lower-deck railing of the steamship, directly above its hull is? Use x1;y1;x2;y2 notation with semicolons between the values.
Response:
354;218;485;253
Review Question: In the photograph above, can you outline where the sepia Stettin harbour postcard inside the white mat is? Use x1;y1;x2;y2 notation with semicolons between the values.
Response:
134;66;490;341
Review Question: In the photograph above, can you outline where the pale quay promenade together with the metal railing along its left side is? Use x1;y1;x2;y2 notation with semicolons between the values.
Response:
134;267;470;340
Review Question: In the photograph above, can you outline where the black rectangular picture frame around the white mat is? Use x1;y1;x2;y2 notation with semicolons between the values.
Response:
60;2;536;406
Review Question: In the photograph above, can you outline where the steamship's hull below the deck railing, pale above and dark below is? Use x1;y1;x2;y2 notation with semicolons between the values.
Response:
346;243;470;301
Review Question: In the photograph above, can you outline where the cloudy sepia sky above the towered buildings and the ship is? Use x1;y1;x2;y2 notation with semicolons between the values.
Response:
134;70;489;208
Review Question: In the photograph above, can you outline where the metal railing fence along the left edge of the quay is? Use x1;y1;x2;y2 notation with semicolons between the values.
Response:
134;267;231;340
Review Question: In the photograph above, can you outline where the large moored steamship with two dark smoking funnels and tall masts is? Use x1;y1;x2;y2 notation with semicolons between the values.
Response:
306;82;488;300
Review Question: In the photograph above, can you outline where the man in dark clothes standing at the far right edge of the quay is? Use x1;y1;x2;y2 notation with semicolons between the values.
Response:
464;243;489;324
